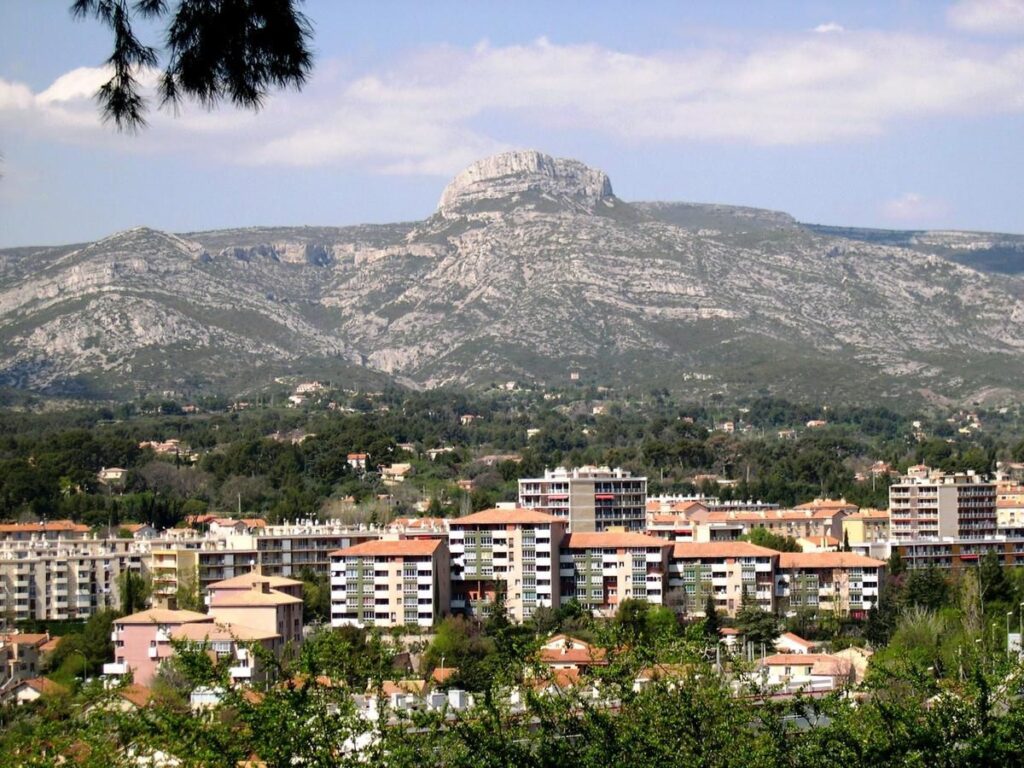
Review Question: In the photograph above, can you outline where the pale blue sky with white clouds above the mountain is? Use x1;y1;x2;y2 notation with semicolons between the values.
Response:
0;0;1024;247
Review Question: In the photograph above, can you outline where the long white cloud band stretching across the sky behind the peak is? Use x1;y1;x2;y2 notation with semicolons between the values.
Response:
0;28;1024;175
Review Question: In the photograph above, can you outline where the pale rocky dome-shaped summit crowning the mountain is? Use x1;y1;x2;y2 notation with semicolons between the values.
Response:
437;150;614;218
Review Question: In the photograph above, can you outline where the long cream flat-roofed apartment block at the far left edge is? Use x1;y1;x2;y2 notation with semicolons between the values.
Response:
0;539;142;626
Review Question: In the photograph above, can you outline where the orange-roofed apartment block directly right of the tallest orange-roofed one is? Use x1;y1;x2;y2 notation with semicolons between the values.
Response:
558;531;674;616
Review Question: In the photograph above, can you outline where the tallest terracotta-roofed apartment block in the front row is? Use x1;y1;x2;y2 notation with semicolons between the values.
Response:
449;508;567;622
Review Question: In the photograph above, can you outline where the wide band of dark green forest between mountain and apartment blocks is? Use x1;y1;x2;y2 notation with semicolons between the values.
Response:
0;388;1024;529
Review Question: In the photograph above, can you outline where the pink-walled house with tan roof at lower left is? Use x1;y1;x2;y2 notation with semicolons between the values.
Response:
103;608;213;686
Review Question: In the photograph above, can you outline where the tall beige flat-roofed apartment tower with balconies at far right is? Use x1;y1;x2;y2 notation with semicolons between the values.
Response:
889;465;997;542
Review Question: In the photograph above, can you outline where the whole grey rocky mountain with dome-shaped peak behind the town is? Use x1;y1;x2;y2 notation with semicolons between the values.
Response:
0;152;1024;401
